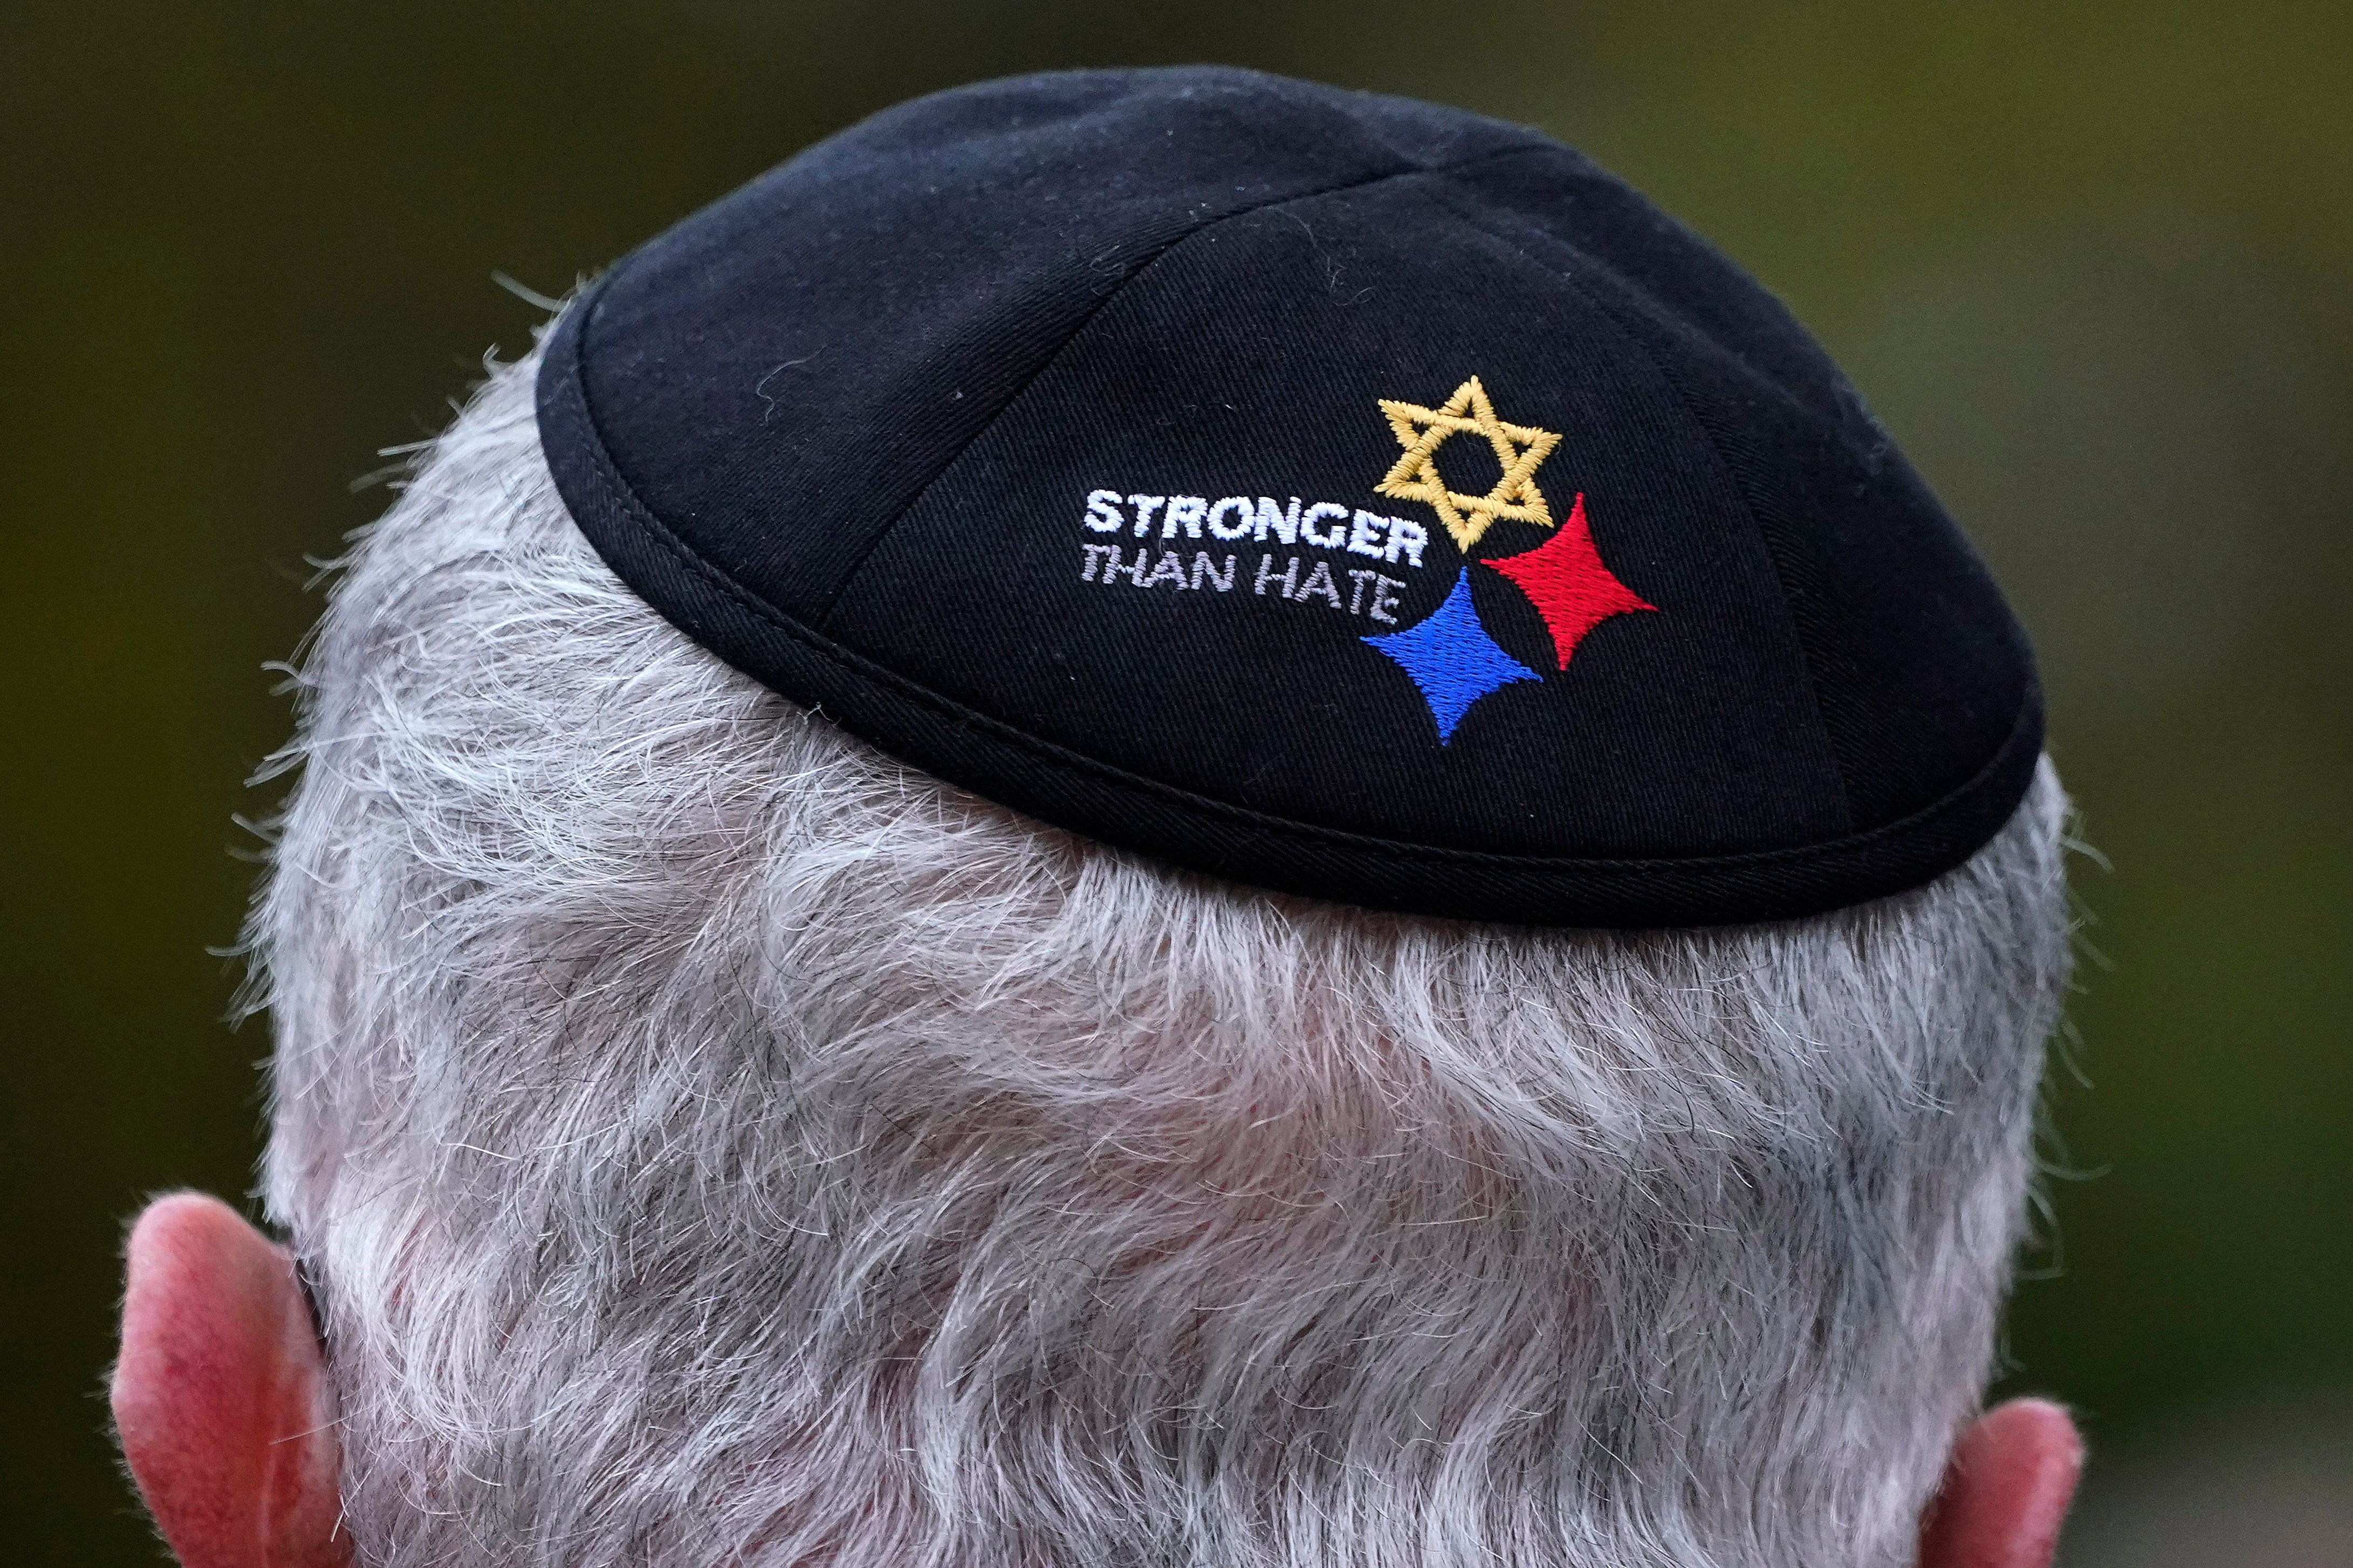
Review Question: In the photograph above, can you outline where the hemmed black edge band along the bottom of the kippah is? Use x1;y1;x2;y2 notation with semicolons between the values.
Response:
537;289;2042;929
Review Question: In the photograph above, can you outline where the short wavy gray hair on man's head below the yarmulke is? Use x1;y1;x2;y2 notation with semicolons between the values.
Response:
249;341;2068;1568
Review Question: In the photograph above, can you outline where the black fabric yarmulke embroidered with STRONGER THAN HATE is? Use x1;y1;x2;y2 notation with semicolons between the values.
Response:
539;68;2042;926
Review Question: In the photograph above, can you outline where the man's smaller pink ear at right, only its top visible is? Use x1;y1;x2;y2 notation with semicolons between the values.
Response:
1920;1399;2082;1568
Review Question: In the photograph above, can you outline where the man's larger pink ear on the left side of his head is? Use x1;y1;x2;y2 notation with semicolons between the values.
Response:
113;1192;351;1568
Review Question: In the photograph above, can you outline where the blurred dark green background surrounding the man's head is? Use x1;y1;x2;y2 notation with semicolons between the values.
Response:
0;0;2353;1568
